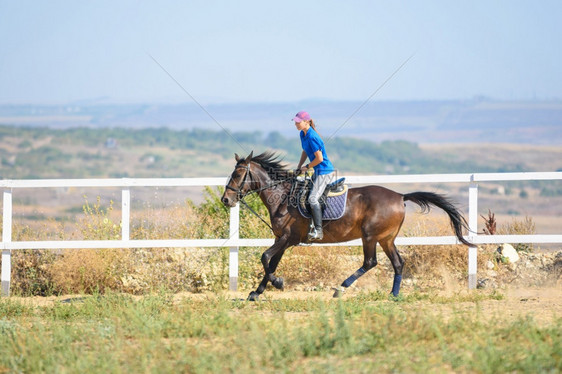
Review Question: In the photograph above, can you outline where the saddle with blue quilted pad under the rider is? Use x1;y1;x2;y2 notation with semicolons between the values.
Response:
291;178;348;220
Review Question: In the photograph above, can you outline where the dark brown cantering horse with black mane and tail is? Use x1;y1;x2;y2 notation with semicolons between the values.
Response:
221;151;472;301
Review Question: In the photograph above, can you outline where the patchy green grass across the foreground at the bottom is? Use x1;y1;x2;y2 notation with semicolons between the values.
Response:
0;292;562;373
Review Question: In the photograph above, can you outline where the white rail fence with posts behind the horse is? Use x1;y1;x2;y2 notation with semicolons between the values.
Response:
0;172;562;296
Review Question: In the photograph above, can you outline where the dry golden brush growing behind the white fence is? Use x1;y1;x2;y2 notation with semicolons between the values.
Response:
2;191;548;295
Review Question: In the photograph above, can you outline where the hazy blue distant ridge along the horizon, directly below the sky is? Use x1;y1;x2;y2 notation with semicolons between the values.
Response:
0;98;562;145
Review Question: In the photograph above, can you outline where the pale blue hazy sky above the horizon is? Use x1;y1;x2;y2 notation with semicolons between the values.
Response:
0;0;562;104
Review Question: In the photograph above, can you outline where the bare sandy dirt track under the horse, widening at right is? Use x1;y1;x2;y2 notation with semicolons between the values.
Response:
11;251;562;324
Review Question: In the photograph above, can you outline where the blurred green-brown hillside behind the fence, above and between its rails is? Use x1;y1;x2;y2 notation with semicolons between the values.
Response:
0;125;562;222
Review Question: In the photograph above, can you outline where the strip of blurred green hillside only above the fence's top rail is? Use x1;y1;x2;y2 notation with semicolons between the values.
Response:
0;126;562;179
